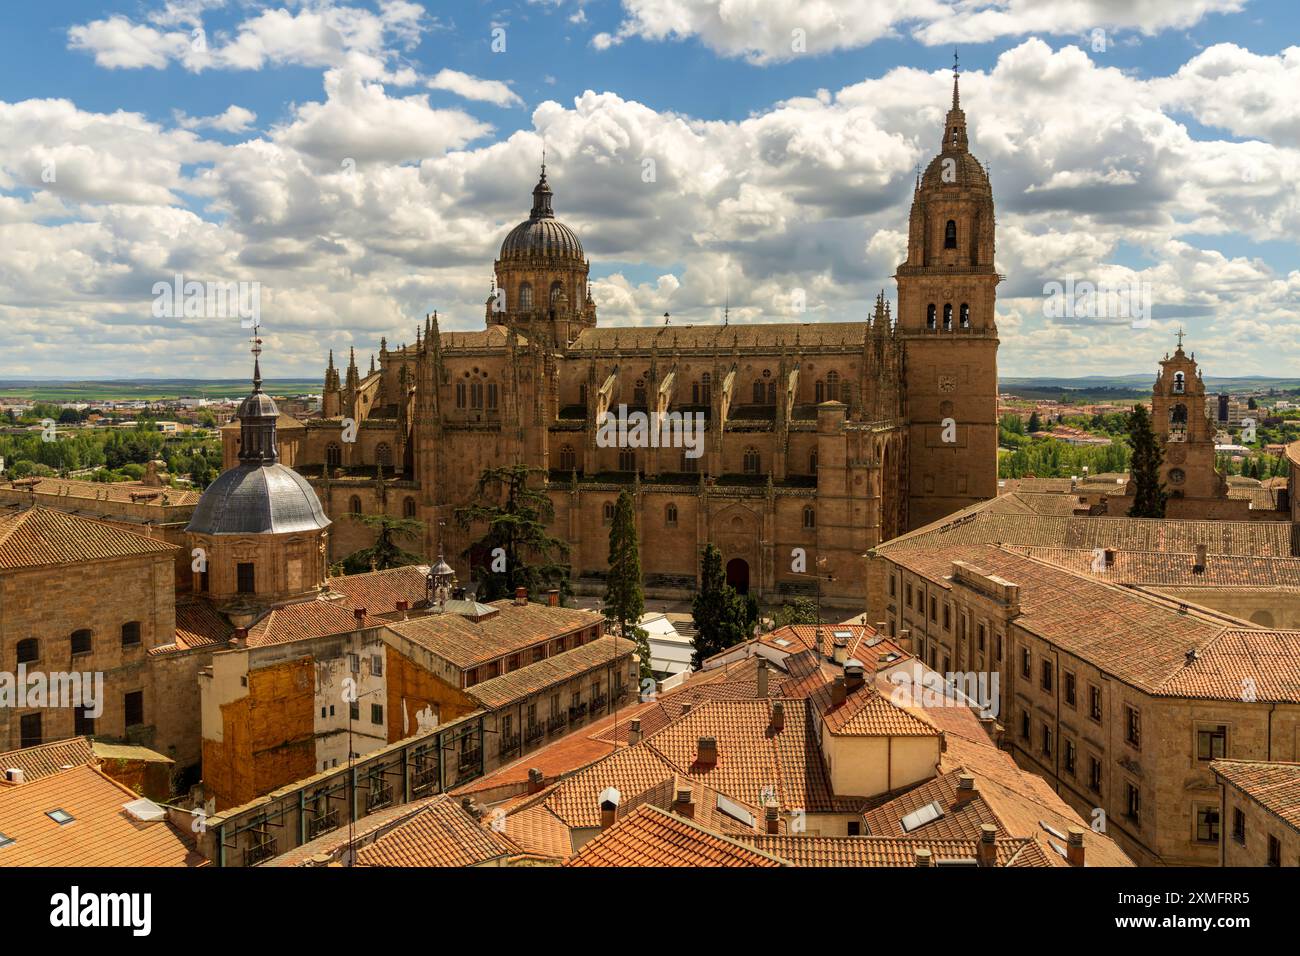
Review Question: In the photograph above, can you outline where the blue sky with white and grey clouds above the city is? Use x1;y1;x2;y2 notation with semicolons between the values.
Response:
0;0;1300;377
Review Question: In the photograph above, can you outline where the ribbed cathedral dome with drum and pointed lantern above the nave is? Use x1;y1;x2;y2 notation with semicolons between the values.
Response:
486;163;595;349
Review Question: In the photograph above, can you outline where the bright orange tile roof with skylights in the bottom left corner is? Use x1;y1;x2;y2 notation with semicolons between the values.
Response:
0;766;207;866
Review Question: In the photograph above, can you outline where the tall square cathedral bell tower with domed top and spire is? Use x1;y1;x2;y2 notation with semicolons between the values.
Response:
894;66;1001;528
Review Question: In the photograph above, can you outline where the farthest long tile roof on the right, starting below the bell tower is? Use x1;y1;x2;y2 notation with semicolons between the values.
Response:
875;496;1291;557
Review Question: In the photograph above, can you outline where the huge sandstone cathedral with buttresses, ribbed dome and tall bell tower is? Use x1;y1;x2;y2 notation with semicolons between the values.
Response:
225;75;1001;607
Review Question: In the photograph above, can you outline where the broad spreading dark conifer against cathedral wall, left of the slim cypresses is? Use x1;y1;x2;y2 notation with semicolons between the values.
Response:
455;464;573;601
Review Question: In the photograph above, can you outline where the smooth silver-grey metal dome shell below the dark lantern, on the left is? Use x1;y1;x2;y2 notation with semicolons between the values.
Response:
186;462;330;535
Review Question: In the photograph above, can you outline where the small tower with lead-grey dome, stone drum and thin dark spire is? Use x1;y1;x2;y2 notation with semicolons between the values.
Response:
186;338;330;616
